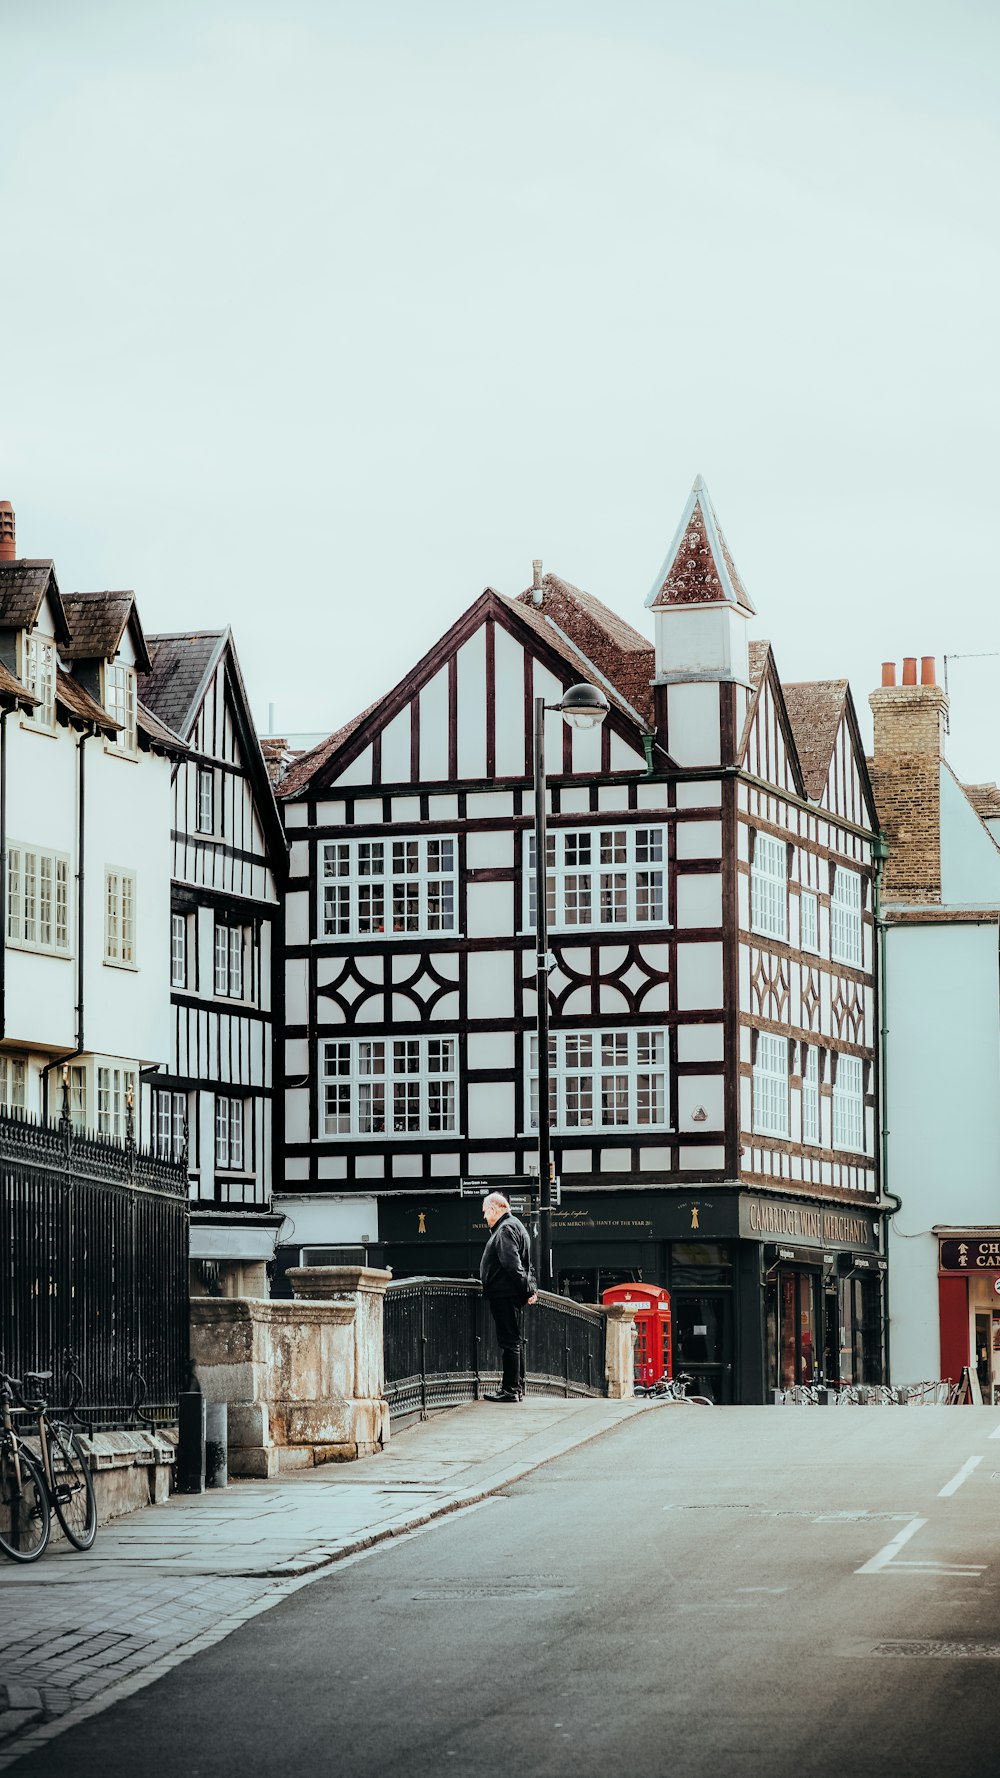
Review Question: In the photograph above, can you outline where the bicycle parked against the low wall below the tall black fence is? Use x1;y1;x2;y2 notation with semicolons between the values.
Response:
0;1371;98;1561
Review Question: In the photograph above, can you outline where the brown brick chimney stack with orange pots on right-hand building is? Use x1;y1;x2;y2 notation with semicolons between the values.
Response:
868;654;948;903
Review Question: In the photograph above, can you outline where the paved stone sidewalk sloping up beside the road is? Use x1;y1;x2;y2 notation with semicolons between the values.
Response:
0;1396;646;1773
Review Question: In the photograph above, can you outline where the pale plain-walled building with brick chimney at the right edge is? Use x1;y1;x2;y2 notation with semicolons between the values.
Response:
870;656;1000;1401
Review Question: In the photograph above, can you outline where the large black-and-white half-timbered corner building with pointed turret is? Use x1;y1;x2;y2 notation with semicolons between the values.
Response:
279;480;884;1401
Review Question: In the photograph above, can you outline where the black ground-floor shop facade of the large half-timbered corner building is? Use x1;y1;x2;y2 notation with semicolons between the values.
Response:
379;1186;886;1403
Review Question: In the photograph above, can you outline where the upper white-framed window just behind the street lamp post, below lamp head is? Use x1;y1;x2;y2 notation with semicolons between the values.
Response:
525;827;667;930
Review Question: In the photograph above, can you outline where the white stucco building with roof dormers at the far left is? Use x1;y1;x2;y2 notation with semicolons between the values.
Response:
0;501;183;1140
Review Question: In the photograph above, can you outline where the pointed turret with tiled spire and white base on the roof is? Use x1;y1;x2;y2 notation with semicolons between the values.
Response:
646;477;756;765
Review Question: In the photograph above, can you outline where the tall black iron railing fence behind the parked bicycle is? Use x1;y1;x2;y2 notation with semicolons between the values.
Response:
0;1106;189;1428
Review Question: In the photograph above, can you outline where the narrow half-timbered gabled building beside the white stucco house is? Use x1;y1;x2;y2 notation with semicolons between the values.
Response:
146;629;286;1296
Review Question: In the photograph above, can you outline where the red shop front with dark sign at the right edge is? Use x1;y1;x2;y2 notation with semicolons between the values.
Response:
934;1229;1000;1406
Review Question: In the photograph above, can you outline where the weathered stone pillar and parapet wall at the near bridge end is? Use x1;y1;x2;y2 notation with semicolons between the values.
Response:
190;1266;390;1476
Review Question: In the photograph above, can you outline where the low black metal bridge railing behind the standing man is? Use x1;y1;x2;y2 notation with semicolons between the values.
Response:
384;1278;607;1417
